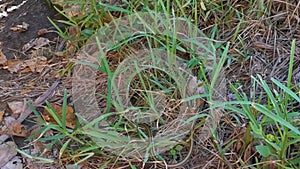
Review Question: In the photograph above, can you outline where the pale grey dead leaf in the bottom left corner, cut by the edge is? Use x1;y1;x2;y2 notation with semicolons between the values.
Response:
0;141;17;167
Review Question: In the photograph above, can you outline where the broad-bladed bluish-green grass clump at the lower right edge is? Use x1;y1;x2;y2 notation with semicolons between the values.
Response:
224;40;300;168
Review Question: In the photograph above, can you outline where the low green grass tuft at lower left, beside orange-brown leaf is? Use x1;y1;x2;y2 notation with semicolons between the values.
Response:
18;90;100;165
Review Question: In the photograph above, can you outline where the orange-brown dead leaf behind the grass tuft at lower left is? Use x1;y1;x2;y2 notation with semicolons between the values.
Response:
42;103;77;129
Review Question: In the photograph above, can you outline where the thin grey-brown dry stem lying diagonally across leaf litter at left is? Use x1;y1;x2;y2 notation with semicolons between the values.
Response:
0;80;60;144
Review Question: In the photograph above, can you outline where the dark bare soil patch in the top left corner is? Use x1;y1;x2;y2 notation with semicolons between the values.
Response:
0;0;62;59
